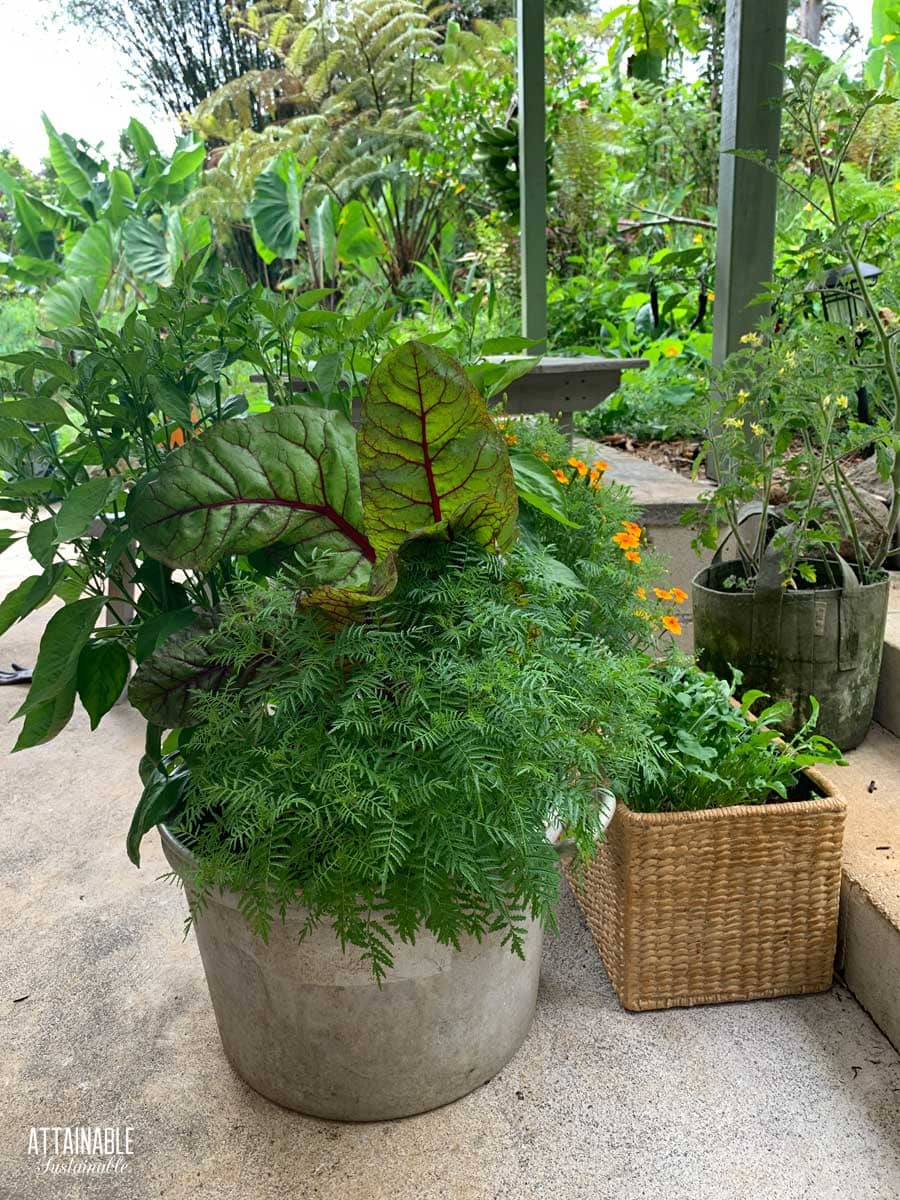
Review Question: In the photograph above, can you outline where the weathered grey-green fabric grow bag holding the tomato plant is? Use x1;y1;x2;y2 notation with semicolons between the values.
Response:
692;560;890;750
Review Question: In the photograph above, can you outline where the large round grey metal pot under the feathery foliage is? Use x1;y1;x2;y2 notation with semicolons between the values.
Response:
160;826;542;1121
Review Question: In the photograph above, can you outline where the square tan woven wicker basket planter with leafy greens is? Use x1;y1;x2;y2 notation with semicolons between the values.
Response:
566;770;846;1012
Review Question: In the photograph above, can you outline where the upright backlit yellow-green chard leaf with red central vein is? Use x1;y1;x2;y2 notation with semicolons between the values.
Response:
358;342;517;557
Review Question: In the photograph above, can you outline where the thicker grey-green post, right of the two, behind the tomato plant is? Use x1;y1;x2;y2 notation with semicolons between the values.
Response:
713;0;787;364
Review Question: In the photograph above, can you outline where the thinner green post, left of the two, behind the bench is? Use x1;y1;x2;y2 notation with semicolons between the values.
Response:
517;0;547;346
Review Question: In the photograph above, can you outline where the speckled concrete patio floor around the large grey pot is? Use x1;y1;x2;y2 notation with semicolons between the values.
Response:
0;540;900;1200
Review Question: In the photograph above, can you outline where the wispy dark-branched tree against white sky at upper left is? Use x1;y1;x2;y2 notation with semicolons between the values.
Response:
65;0;276;128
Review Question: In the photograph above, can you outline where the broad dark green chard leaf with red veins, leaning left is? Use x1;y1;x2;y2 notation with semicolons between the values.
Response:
127;407;376;586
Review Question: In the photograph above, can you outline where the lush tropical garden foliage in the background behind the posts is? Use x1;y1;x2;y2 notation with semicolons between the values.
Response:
0;0;900;437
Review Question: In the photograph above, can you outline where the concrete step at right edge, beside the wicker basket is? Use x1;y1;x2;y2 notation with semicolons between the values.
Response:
827;725;900;1048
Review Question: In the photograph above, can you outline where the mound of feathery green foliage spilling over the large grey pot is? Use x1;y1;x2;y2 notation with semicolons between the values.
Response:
175;539;648;973
